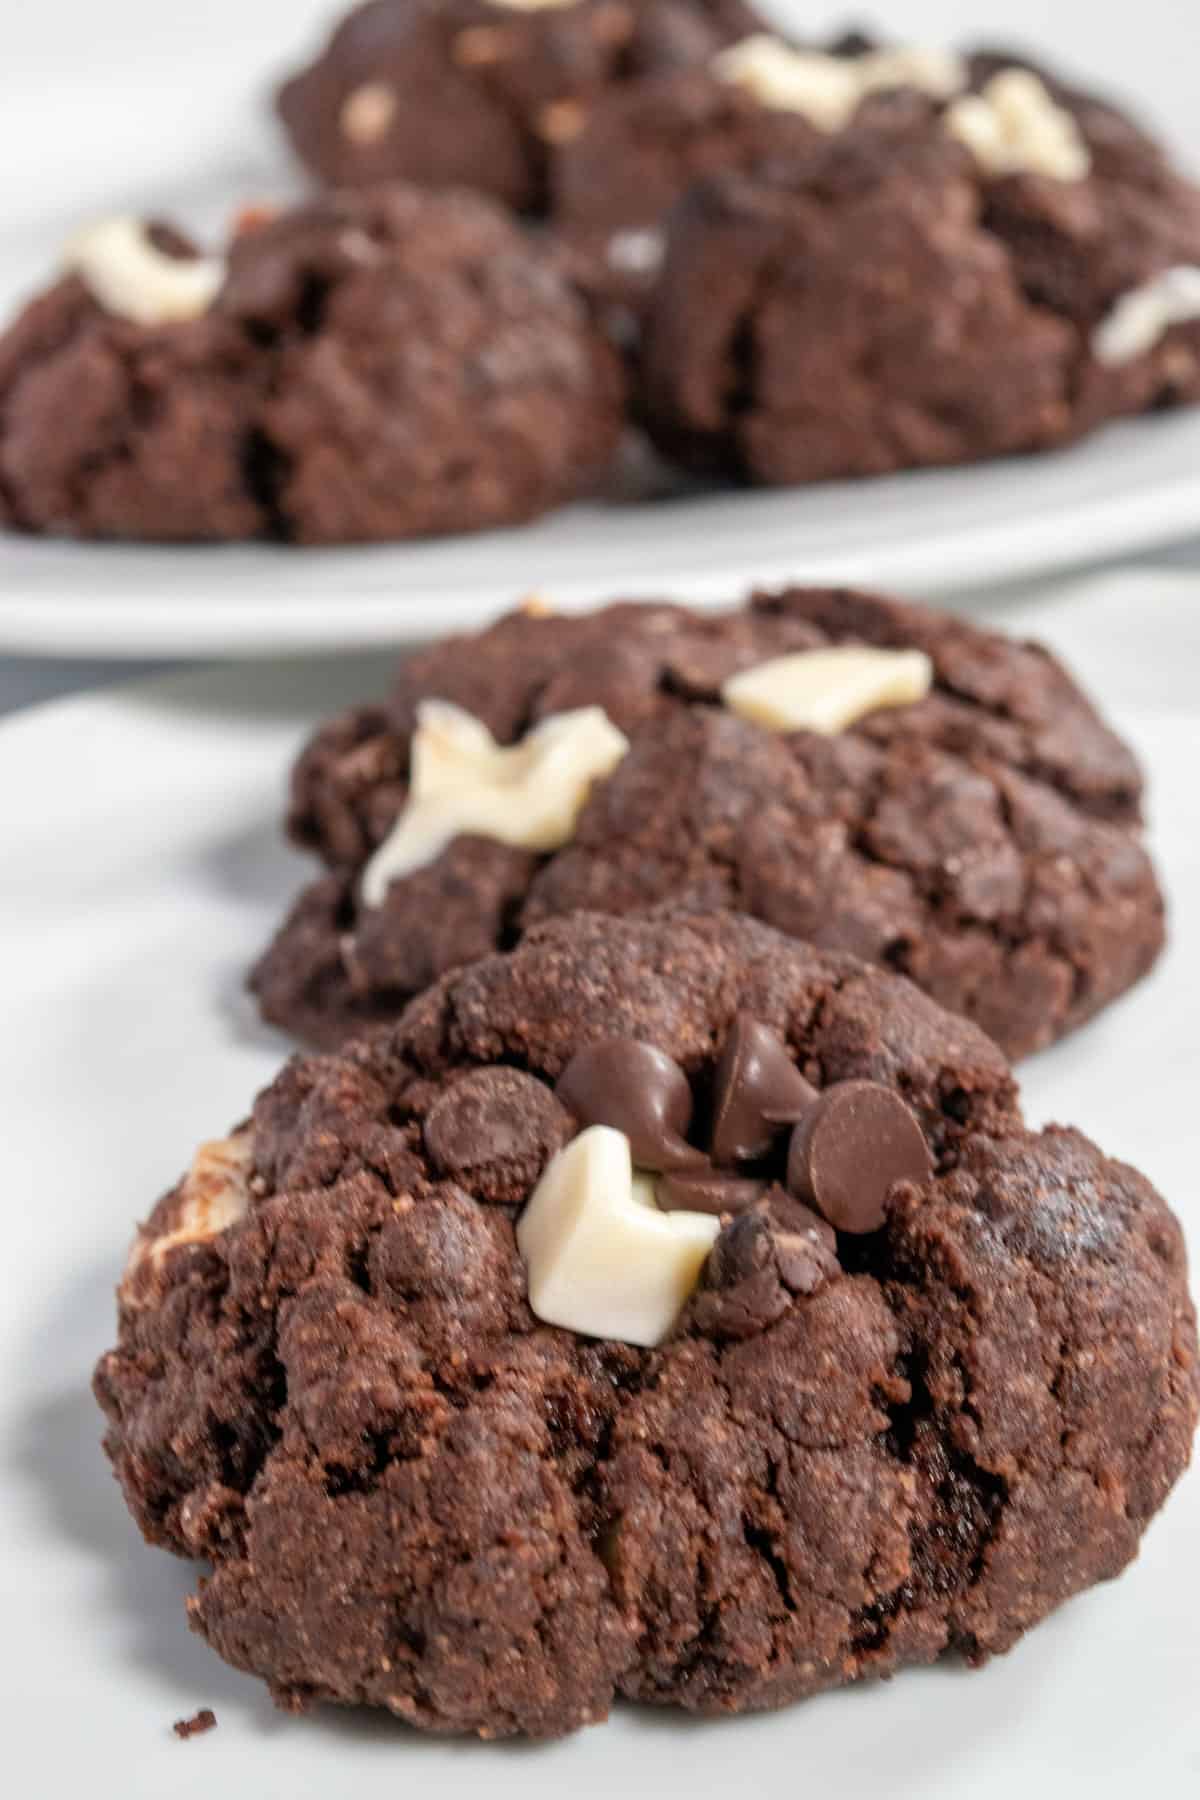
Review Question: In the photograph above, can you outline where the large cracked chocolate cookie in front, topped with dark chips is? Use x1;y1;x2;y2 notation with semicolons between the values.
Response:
95;913;1200;1737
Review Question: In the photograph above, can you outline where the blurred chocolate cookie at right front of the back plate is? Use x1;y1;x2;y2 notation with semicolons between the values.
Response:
644;52;1200;484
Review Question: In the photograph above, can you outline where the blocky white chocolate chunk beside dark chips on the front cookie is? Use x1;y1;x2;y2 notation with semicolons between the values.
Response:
516;1125;721;1348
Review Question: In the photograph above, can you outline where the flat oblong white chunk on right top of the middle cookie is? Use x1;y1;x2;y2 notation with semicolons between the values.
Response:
721;644;934;736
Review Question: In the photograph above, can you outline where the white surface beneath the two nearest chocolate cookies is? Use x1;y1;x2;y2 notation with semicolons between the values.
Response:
0;578;1200;1800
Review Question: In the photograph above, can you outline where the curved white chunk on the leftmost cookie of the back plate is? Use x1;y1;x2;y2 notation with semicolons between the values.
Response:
63;216;225;326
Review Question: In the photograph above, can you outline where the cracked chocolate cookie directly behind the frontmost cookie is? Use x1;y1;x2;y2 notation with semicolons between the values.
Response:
252;589;1164;1055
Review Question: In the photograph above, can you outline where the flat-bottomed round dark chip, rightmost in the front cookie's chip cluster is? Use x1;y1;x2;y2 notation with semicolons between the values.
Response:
788;1082;934;1233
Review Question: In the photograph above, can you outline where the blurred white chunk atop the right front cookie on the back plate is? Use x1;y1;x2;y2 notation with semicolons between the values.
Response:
946;68;1092;182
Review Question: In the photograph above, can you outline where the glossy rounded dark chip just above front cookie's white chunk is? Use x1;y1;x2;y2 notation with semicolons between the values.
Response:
556;1037;707;1174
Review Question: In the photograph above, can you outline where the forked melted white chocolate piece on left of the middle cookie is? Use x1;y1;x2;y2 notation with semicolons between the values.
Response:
362;700;630;905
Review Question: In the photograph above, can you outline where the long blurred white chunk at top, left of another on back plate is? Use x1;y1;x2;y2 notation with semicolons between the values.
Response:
712;32;966;131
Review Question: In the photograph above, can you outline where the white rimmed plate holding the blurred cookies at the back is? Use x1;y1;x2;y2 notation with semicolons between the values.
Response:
0;0;1200;657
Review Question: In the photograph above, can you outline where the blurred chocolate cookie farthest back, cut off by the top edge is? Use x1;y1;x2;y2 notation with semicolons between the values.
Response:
279;0;757;211
